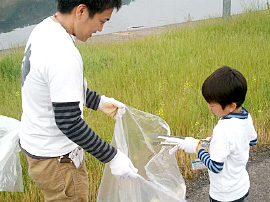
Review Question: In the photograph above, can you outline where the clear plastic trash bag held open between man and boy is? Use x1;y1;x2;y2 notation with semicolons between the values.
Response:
97;107;186;202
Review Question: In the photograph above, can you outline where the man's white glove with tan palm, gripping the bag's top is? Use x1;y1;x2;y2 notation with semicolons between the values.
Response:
98;95;125;118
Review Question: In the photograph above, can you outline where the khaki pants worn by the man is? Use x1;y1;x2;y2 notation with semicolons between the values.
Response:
24;154;89;202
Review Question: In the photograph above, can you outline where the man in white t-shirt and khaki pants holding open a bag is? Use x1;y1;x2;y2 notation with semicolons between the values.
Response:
19;0;138;201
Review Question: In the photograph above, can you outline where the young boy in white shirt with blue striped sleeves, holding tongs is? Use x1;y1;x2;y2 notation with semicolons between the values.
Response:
170;67;257;202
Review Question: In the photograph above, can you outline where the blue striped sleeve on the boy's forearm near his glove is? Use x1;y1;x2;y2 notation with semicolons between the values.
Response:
198;149;224;173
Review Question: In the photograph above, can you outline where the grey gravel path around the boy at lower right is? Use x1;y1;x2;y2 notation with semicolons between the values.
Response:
186;145;270;202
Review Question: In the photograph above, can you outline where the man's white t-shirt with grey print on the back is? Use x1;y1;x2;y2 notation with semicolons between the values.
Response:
19;17;84;157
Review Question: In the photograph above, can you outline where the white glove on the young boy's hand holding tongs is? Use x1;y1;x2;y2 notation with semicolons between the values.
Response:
169;137;200;155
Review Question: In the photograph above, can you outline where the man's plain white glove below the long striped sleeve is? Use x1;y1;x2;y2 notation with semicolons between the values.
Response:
110;149;139;179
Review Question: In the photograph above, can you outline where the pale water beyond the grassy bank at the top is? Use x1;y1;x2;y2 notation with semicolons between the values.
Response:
0;0;267;50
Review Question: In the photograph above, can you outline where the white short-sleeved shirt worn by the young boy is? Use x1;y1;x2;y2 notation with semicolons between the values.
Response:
209;114;257;201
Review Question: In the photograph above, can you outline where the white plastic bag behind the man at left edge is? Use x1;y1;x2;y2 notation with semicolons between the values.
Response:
0;115;23;192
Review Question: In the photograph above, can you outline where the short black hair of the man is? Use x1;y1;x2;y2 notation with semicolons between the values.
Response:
57;0;122;17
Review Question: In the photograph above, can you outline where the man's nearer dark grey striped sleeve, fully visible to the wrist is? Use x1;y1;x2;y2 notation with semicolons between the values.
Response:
52;102;116;163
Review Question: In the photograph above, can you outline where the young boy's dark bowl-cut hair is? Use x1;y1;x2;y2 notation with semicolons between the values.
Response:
202;66;247;109
